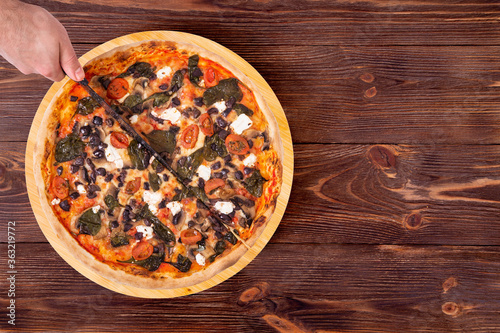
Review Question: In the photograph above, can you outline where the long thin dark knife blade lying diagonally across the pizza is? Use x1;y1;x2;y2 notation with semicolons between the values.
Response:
76;79;250;249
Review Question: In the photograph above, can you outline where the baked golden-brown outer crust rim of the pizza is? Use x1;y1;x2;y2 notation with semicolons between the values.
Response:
33;40;283;289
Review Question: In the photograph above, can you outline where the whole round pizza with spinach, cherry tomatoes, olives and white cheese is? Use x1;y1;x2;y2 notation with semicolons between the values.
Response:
34;40;283;289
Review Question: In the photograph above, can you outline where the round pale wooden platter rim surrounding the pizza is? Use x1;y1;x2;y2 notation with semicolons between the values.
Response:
25;31;293;298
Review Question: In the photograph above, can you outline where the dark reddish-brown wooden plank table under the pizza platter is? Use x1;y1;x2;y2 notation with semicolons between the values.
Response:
0;0;500;332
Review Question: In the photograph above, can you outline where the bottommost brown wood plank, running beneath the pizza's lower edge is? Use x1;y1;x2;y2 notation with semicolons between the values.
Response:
0;244;500;332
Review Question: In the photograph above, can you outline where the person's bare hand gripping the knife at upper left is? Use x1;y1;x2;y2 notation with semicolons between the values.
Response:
0;0;85;81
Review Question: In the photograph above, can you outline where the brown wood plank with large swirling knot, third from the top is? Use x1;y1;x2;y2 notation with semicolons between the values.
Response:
5;143;500;245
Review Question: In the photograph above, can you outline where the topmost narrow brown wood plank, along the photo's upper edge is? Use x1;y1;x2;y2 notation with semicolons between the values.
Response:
35;0;500;45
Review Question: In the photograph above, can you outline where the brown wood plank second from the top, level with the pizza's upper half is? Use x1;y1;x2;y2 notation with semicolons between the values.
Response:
0;44;500;144
